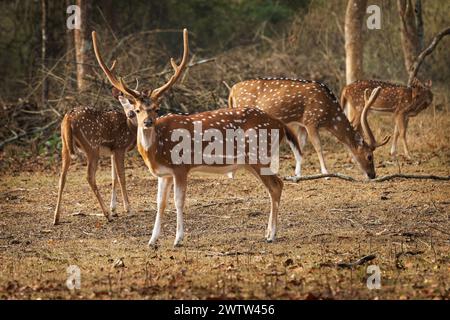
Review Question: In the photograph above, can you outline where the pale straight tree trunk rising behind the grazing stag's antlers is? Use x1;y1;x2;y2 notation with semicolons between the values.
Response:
345;0;367;84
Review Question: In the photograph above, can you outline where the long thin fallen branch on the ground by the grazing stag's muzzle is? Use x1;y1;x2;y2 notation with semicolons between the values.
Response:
284;173;450;183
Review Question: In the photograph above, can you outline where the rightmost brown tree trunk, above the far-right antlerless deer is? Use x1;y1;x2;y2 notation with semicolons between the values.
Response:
397;0;423;72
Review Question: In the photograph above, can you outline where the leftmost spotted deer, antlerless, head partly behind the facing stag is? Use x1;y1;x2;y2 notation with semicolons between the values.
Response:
53;89;137;225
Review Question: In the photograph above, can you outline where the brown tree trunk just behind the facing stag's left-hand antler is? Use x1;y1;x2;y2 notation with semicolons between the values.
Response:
74;0;89;91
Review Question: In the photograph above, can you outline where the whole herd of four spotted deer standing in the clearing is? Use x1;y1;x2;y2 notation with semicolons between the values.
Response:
54;29;433;246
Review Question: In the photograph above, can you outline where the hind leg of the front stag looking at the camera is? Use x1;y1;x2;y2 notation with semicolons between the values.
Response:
249;167;283;242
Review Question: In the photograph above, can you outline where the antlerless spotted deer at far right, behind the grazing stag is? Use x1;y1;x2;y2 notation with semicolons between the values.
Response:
341;79;433;159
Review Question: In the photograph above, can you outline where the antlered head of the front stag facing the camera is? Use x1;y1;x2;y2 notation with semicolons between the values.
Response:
92;29;189;129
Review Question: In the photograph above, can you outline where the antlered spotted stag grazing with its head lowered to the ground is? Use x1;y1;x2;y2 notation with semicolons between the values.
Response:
228;78;389;179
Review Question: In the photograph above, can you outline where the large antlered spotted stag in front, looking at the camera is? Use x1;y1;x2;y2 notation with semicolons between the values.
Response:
92;29;300;246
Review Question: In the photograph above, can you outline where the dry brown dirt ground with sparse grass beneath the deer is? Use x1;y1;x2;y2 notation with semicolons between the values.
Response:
0;109;450;299
